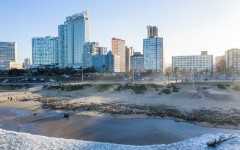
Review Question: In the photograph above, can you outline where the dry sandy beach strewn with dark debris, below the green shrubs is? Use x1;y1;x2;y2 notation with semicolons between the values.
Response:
0;84;240;129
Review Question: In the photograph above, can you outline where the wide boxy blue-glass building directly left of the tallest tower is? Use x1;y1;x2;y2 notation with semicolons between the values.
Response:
32;36;58;67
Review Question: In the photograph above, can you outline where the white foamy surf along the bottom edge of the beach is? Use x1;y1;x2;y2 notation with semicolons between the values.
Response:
0;129;240;150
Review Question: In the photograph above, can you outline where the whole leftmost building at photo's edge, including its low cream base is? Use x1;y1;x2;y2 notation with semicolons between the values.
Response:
0;42;22;70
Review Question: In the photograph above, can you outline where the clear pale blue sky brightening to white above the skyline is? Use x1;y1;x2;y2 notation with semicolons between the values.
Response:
0;0;240;63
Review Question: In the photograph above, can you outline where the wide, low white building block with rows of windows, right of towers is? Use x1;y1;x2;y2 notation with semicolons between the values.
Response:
172;51;213;72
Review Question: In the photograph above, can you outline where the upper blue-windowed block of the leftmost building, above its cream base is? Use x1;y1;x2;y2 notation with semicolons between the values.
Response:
0;42;17;62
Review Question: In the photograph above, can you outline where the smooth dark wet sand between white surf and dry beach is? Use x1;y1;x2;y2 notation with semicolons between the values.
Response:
0;108;240;145
